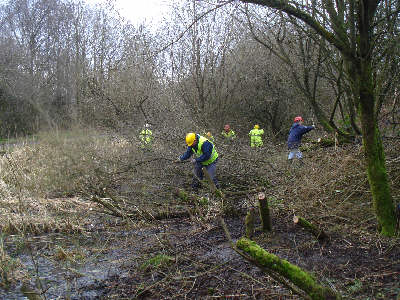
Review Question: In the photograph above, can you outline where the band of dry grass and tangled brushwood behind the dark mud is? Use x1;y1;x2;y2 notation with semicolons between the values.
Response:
0;130;400;293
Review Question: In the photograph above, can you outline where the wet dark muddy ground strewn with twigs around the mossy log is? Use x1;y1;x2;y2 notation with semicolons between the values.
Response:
3;202;400;299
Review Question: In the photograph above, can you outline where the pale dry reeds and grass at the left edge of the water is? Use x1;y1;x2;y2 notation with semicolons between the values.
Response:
0;127;134;234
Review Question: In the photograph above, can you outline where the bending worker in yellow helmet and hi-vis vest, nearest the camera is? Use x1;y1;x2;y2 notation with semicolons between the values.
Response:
179;132;219;191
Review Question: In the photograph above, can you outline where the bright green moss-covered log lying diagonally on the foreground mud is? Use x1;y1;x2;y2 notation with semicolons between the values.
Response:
236;238;341;300
